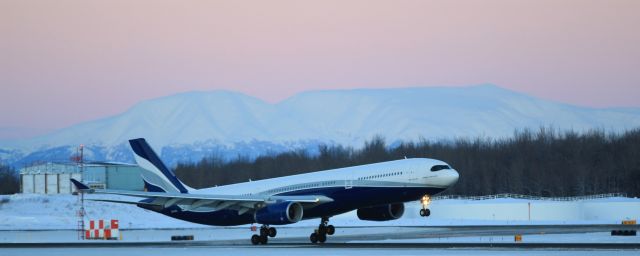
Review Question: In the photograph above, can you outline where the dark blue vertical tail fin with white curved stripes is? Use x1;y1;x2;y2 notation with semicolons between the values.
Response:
129;138;191;193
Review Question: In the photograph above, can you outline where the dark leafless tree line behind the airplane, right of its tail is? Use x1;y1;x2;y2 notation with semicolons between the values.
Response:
175;128;640;196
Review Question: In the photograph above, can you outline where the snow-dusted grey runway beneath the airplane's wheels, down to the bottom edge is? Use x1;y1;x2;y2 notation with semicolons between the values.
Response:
0;225;640;256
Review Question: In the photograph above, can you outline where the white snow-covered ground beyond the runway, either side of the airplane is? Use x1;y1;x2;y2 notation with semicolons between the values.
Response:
0;194;640;230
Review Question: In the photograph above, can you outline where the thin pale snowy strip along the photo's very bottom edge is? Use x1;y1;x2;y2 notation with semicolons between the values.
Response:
0;244;640;256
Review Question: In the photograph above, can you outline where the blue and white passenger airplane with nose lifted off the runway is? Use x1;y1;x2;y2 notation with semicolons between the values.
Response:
71;138;458;245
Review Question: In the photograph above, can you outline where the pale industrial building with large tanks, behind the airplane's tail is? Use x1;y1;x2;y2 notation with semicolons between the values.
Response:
20;163;144;194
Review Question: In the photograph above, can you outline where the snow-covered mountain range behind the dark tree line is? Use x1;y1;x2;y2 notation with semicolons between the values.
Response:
0;85;640;166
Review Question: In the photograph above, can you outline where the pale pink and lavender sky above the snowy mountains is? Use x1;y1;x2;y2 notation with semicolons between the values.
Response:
0;0;640;139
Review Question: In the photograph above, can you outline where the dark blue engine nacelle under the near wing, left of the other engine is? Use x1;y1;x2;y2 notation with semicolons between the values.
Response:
253;202;302;225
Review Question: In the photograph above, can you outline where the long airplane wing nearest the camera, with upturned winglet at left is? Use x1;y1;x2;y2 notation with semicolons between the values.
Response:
71;179;333;214
